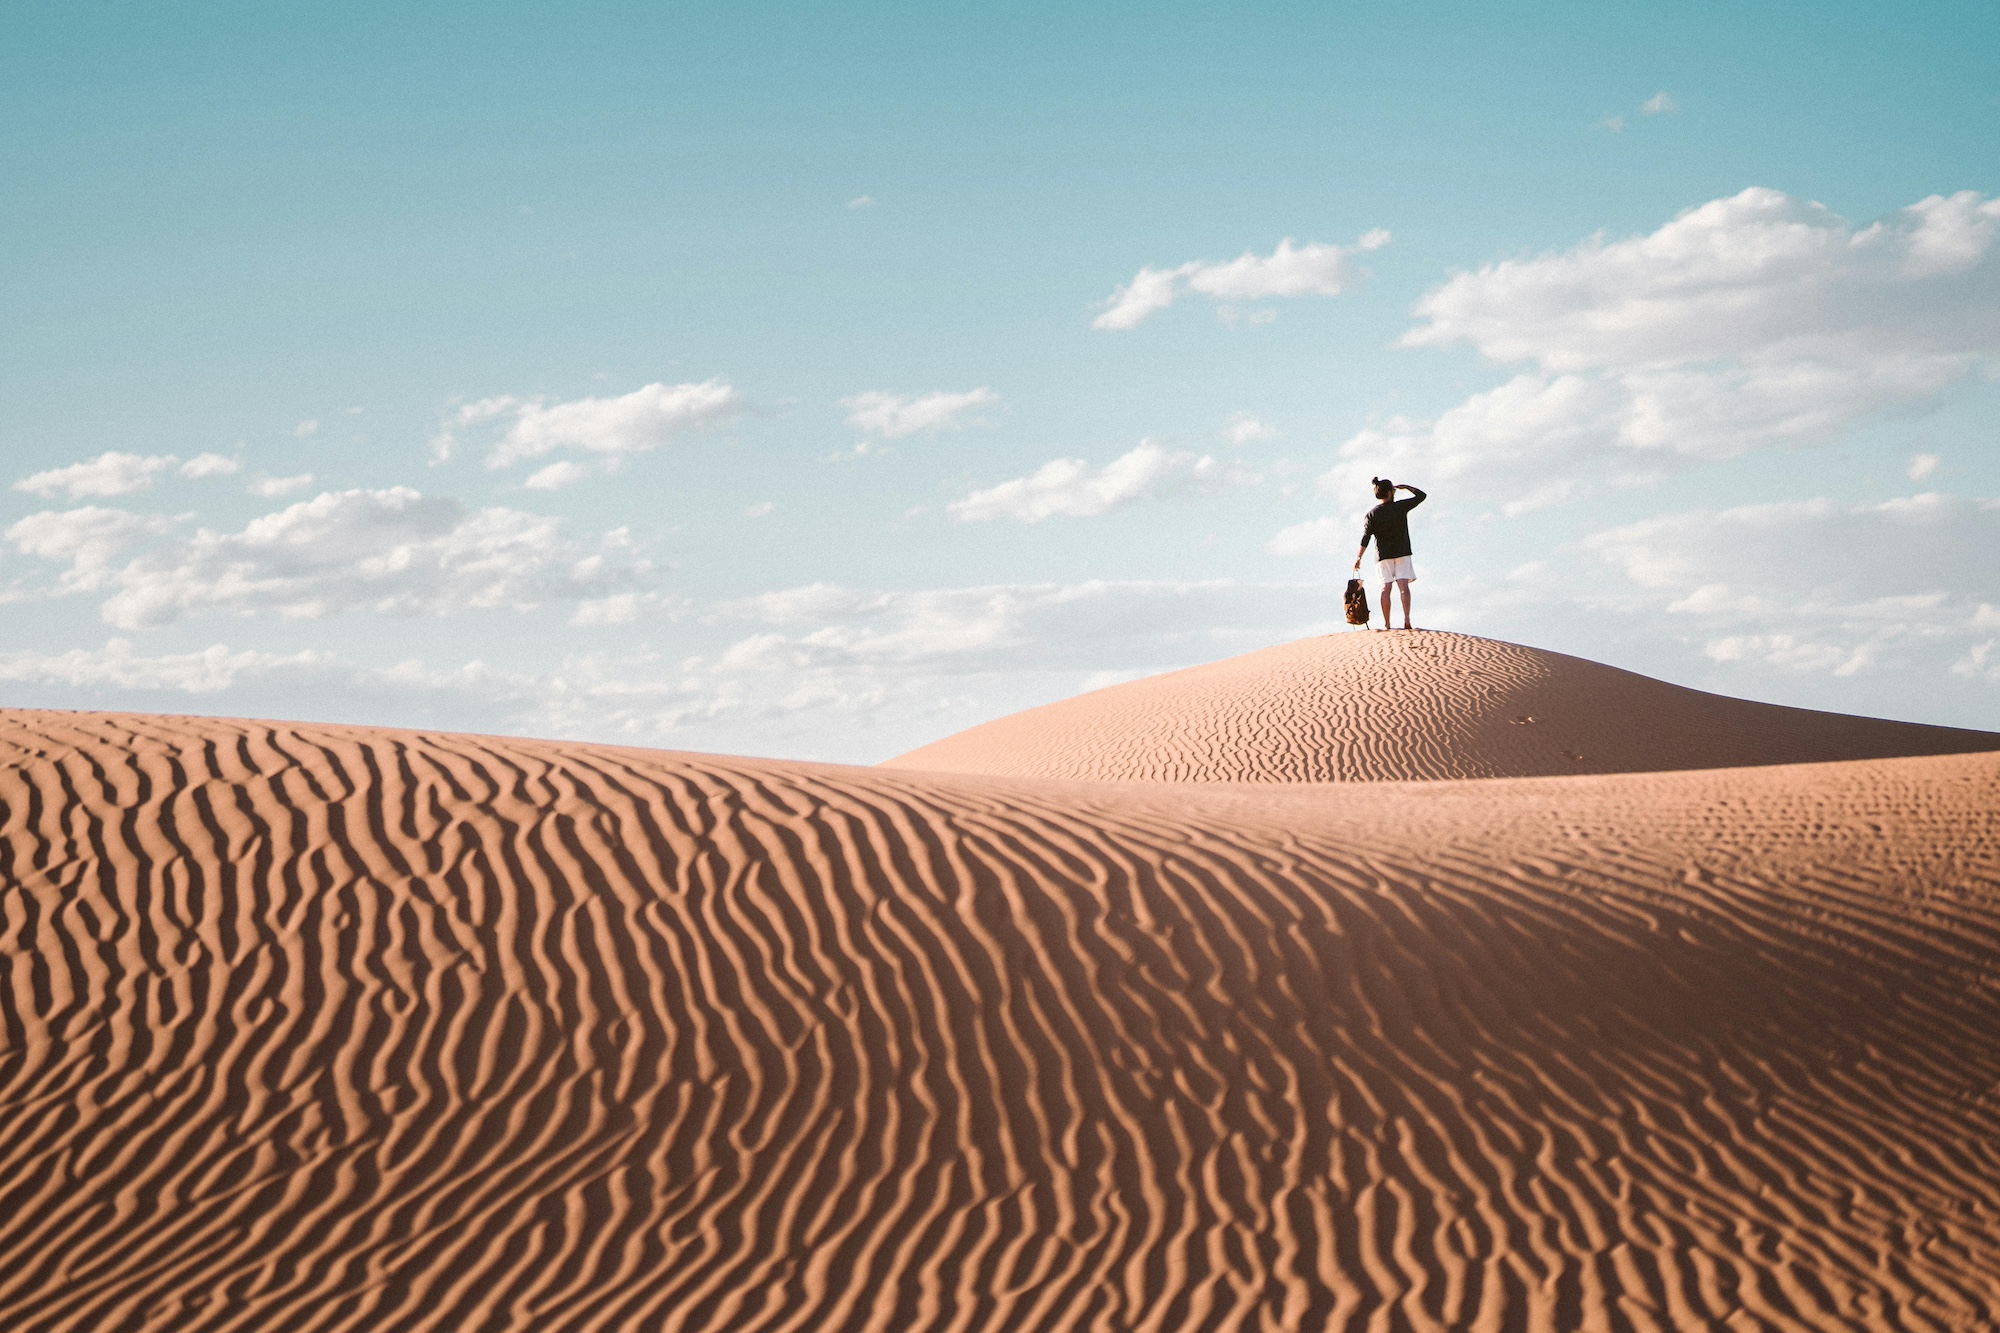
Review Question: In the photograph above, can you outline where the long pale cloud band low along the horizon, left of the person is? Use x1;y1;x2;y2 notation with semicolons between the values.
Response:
0;580;1334;763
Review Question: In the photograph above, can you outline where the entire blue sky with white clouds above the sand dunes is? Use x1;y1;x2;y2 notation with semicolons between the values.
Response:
0;0;2000;763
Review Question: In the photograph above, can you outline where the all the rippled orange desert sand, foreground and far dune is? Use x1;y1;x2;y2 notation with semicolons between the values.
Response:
0;634;2000;1331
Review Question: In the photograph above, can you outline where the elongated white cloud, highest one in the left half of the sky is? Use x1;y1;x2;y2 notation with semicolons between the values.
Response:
430;380;744;468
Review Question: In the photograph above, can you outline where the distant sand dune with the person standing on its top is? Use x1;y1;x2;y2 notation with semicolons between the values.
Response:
888;630;2000;783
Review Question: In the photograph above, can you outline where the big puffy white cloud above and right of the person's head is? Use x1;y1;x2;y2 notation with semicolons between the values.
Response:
1324;190;2000;512
